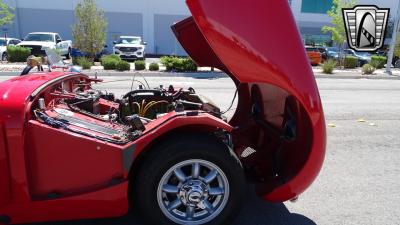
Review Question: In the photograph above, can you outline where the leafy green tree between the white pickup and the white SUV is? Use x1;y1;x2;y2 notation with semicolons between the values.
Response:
72;0;108;60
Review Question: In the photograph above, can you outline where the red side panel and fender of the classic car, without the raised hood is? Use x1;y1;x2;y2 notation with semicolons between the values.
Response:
0;73;232;223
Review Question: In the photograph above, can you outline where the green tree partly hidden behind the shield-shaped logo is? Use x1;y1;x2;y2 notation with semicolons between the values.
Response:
322;0;356;65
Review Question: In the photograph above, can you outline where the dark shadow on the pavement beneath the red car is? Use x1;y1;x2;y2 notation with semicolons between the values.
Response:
25;187;316;225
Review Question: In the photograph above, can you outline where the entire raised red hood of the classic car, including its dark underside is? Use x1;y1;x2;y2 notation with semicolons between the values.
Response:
172;0;326;201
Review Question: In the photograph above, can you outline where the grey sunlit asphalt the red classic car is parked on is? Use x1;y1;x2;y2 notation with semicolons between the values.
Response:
0;77;400;225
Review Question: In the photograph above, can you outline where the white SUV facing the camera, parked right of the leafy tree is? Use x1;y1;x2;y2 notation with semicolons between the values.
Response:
113;36;146;60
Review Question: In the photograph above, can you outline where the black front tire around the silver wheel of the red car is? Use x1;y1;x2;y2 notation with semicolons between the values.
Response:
130;134;246;225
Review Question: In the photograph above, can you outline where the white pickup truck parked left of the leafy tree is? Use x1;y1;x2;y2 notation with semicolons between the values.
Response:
18;32;72;59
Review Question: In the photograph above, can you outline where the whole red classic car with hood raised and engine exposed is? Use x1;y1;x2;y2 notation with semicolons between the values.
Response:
0;0;326;224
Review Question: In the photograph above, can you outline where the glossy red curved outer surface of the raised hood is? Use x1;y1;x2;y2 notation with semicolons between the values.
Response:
187;0;326;201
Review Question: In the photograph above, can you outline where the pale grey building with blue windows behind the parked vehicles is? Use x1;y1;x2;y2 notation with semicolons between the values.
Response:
1;0;398;55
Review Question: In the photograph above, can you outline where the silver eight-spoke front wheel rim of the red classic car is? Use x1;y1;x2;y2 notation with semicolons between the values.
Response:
157;159;229;225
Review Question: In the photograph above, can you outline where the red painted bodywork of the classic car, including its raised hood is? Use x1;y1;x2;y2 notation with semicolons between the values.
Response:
0;0;326;223
